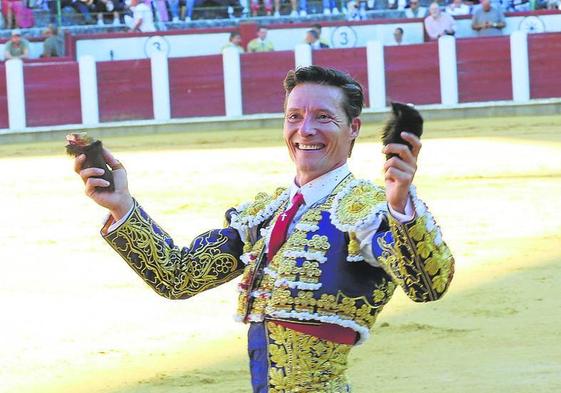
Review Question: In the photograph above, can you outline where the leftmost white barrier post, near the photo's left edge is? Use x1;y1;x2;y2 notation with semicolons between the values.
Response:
6;59;26;130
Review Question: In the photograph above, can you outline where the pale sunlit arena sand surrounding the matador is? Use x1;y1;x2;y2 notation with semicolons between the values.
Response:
0;117;561;393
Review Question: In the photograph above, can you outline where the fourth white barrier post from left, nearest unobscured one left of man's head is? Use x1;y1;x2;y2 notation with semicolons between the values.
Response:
222;47;243;117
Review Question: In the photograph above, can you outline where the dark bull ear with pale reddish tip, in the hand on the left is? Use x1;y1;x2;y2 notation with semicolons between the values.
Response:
66;132;115;192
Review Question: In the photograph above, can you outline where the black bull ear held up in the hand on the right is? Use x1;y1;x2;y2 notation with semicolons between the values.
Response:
382;102;423;159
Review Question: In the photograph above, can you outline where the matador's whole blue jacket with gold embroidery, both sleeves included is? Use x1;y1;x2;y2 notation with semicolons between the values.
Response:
104;175;454;342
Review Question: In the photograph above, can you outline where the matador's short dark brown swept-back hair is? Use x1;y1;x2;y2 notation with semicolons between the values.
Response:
284;65;364;123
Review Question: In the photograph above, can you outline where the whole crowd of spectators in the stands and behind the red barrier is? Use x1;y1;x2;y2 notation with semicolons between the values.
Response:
0;0;561;59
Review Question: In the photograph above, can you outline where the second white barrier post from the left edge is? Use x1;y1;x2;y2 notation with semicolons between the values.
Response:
78;56;99;125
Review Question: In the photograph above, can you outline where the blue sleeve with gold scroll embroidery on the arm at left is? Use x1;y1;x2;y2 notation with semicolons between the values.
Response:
101;201;244;299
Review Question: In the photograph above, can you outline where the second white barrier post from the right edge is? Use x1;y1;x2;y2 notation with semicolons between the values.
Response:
438;35;458;105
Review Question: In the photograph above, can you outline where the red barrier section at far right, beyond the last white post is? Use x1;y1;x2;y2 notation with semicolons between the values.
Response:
528;33;561;98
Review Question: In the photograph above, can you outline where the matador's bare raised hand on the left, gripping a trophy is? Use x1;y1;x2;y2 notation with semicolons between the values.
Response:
74;148;134;221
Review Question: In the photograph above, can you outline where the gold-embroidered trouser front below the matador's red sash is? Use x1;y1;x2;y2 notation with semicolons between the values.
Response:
267;322;351;393
